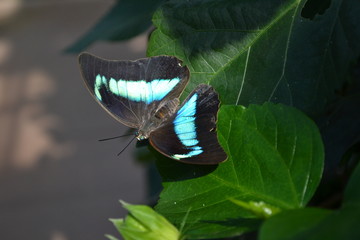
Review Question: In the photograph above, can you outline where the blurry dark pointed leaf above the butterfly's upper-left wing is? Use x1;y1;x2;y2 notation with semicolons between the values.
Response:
65;0;164;53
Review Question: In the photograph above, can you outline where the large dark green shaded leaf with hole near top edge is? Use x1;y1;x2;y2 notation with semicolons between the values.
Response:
148;0;360;115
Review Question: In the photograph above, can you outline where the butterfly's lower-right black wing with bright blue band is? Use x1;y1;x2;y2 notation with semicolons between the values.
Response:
150;84;227;164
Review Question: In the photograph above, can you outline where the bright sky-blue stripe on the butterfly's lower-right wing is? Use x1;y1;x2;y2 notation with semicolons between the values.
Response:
172;93;203;160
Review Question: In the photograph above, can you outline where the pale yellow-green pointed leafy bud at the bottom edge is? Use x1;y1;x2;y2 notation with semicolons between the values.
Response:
110;201;180;240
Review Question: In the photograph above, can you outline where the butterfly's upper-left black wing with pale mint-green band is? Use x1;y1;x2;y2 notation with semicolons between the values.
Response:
79;53;189;128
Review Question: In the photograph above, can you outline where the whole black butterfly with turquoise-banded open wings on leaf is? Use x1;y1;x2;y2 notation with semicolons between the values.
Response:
79;53;227;164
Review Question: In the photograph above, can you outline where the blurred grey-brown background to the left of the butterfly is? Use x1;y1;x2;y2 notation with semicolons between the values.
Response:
0;0;147;240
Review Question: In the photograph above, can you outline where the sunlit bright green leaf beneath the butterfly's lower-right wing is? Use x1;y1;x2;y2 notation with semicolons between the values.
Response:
155;103;324;238
